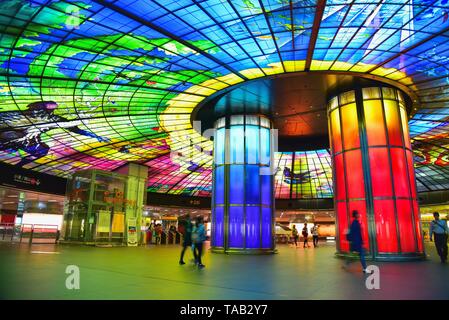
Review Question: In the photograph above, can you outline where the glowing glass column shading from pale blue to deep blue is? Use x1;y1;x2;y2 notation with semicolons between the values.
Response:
211;115;275;254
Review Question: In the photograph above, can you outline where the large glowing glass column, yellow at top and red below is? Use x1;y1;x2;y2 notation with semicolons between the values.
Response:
328;87;424;260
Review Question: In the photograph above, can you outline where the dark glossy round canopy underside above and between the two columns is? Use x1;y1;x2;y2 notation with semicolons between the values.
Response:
192;72;410;151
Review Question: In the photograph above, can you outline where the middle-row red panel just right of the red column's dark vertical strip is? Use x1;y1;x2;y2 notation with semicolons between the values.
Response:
369;148;393;197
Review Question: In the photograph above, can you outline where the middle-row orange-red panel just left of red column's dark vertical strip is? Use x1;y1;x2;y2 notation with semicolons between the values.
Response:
345;149;365;199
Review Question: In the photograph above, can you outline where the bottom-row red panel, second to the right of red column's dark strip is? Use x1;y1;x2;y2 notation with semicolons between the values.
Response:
396;200;415;252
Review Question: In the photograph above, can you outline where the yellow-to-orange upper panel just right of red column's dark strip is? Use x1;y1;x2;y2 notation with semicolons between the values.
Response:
363;100;387;146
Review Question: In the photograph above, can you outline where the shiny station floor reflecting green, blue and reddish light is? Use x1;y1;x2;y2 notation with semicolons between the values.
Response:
0;242;449;300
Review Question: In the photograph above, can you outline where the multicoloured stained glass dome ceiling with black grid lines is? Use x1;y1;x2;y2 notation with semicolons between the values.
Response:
0;0;449;198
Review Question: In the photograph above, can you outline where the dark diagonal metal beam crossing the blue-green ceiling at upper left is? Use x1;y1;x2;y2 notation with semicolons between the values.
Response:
93;0;248;80
